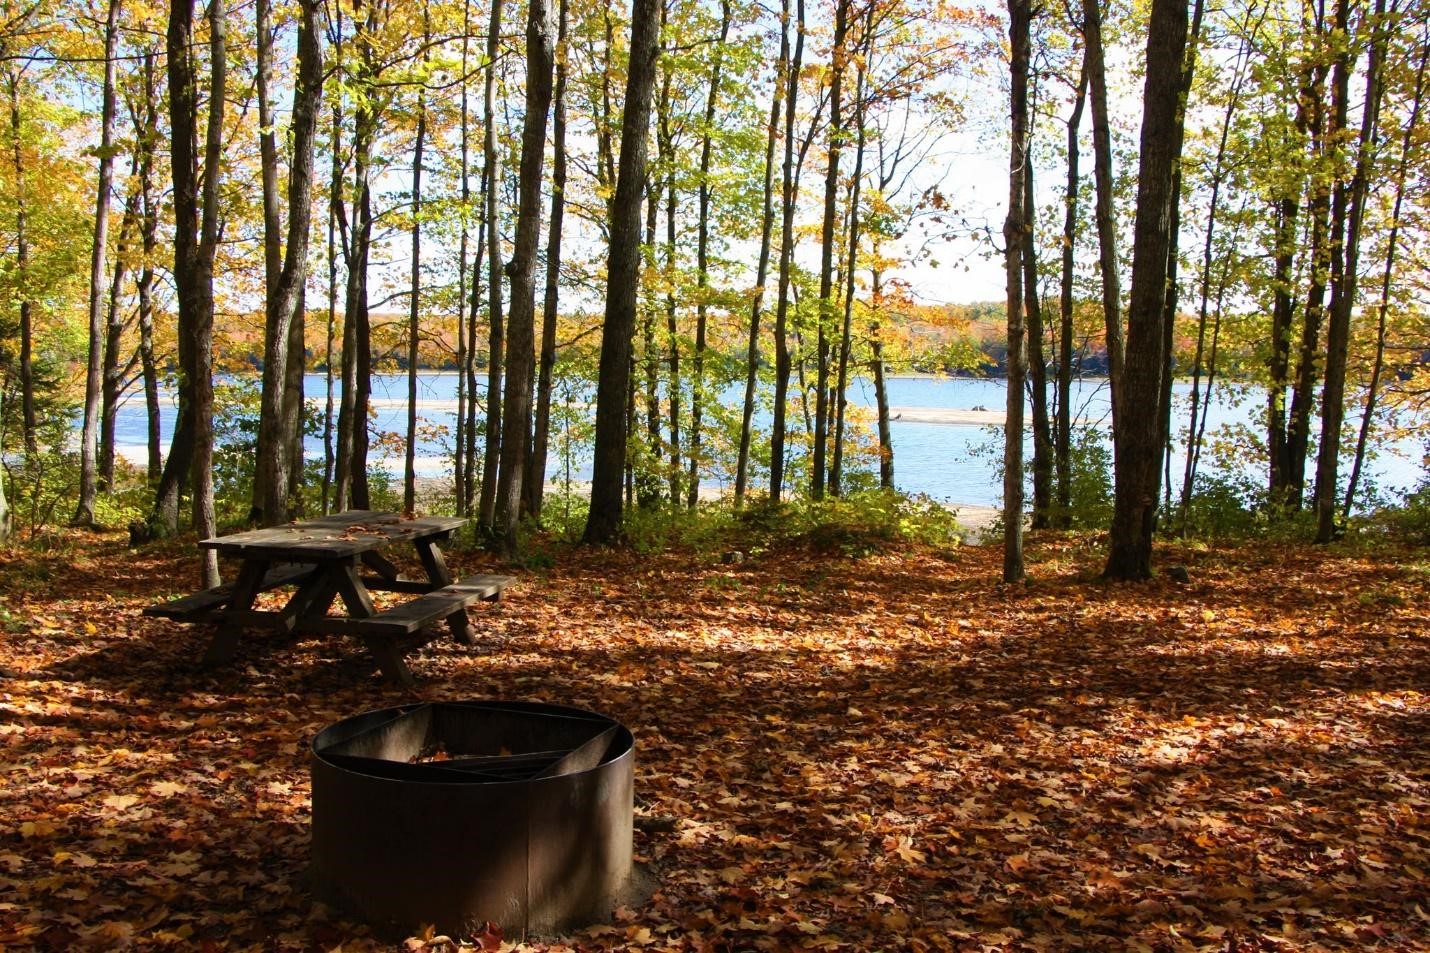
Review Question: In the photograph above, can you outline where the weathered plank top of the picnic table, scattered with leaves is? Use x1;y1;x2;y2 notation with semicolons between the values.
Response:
199;509;466;561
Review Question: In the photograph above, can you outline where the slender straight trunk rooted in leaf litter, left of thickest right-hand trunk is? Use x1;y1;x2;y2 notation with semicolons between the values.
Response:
1002;0;1032;582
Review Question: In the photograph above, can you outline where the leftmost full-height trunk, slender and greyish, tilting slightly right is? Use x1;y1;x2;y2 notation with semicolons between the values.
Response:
70;0;120;527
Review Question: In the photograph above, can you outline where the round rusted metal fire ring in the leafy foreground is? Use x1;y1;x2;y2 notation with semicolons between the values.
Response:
312;701;633;937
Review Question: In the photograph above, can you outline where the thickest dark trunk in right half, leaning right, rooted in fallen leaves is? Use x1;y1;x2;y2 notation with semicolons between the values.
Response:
1104;0;1187;580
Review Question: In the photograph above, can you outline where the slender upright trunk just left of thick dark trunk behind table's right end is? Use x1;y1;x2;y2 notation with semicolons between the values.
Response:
476;0;506;526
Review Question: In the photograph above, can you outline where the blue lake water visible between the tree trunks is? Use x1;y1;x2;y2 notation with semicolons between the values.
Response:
117;373;1424;507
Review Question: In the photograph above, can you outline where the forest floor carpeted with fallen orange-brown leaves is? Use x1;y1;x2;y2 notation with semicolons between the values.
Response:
0;523;1430;952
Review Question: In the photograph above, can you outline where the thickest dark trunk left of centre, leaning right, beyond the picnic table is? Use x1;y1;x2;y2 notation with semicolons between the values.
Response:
585;0;661;544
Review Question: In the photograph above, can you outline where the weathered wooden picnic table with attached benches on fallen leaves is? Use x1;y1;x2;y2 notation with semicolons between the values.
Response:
144;509;513;685
